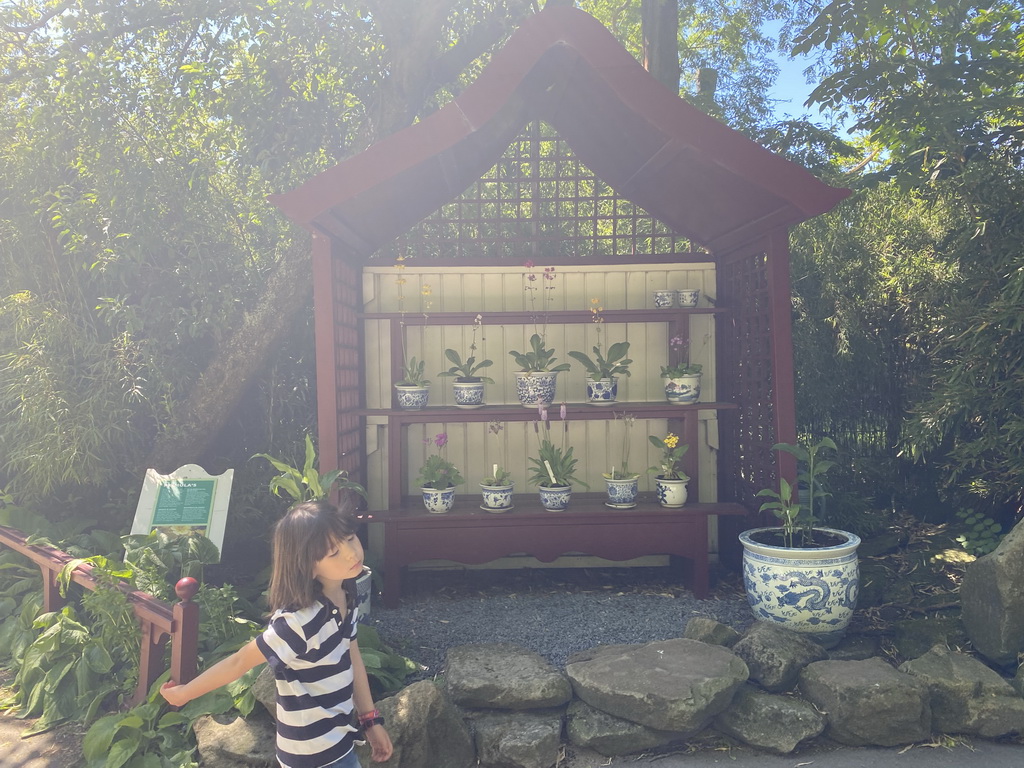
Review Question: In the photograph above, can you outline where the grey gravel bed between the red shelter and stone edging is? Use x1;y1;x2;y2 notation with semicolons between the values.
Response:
371;568;753;682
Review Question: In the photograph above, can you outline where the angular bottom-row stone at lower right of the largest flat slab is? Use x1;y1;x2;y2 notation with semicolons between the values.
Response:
715;685;828;755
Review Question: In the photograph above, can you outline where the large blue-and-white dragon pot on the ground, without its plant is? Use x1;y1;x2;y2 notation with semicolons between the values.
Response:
739;527;860;648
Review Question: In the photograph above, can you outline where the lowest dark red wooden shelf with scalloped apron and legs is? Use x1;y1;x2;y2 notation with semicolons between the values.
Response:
367;494;748;607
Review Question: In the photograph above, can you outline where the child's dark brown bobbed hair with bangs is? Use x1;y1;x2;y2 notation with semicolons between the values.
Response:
267;501;358;612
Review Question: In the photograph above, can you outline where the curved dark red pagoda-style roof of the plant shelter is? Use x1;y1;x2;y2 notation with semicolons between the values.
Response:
270;7;850;257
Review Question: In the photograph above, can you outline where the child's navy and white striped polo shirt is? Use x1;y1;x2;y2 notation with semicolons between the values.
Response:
256;598;358;768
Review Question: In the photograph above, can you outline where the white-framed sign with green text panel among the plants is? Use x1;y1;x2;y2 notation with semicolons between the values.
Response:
131;464;234;551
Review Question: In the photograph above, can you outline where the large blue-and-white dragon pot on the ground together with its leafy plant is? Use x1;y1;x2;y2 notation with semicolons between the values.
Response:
739;437;860;646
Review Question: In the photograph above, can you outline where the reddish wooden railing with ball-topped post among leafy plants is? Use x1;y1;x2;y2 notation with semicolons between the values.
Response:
0;525;199;706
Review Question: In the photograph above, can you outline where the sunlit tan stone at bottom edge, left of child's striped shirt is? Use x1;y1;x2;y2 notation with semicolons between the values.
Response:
194;714;278;768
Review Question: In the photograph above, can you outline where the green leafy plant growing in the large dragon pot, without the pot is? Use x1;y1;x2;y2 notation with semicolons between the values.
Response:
757;437;837;548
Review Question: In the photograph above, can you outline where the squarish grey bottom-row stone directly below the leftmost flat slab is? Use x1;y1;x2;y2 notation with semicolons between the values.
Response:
475;712;562;768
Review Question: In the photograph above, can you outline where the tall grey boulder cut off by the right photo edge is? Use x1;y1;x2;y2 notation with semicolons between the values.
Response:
961;522;1024;667
